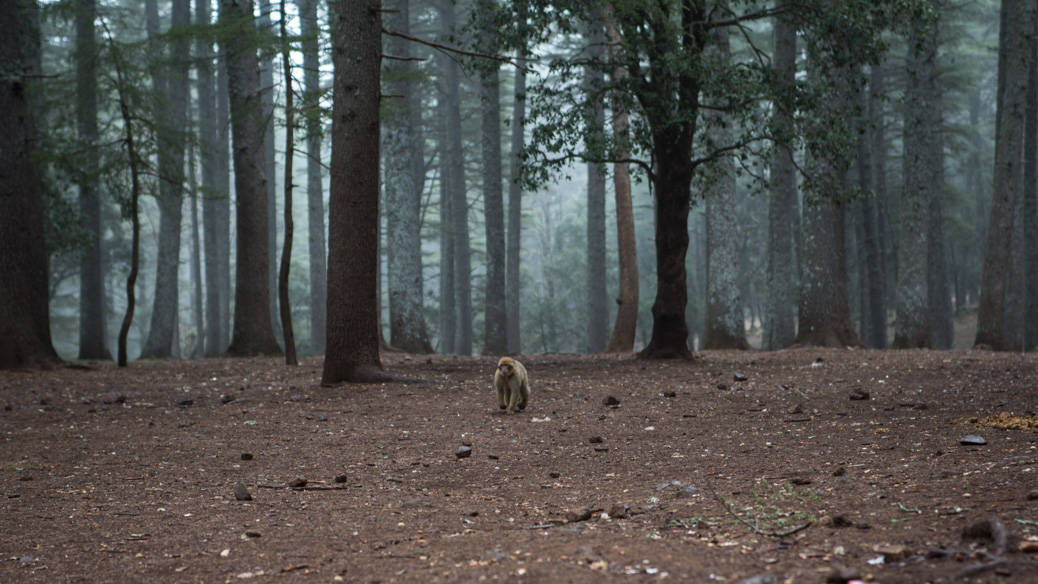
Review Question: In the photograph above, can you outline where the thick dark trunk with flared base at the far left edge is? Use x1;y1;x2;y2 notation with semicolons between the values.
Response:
0;0;59;369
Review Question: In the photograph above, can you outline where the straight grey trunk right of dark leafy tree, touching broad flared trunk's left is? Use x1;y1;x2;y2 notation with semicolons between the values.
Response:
763;10;797;351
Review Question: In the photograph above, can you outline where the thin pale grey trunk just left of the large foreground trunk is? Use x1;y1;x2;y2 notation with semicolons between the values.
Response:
299;0;328;355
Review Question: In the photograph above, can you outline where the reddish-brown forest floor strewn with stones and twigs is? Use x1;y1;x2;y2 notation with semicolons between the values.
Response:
0;349;1038;584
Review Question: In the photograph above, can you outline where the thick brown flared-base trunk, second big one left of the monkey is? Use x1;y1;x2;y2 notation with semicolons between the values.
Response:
220;0;281;356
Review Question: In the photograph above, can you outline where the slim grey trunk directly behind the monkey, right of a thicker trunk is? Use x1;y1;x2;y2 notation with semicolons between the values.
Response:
504;10;526;355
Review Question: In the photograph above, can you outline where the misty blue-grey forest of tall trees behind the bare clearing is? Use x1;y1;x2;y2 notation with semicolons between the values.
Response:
5;0;1038;369
